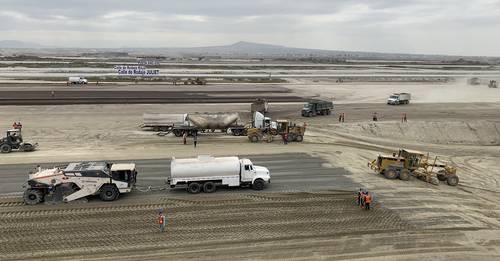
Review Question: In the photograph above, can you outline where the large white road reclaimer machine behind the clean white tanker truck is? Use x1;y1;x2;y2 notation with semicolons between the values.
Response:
23;159;137;205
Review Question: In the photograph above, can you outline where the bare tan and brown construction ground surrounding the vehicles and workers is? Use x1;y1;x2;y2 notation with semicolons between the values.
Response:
0;80;500;260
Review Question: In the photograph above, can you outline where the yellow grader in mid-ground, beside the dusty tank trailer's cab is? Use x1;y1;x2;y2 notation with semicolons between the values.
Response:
247;120;306;142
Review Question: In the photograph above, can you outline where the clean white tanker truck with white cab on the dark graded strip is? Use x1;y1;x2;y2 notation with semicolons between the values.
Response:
166;155;271;194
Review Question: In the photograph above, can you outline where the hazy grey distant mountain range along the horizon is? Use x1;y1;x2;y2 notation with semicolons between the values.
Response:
0;40;499;63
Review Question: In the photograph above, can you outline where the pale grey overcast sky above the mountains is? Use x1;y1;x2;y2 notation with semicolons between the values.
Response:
0;0;500;56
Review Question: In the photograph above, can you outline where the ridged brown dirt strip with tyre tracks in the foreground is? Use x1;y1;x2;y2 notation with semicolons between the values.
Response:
0;190;411;259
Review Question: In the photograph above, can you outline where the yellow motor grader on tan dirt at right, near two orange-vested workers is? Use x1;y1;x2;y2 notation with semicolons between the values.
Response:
368;149;459;186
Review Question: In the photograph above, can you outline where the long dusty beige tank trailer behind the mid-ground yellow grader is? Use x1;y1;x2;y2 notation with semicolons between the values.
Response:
140;113;246;137
